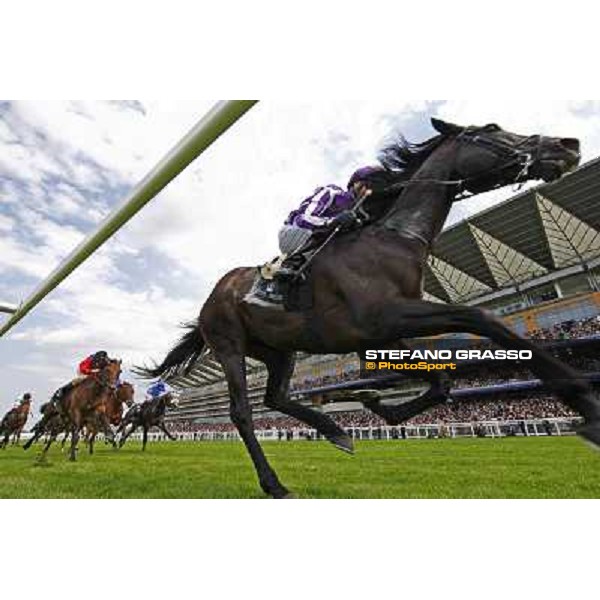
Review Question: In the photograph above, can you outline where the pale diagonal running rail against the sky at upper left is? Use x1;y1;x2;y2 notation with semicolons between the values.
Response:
0;100;257;337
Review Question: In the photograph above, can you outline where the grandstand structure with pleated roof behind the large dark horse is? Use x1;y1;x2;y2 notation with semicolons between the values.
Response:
170;159;600;423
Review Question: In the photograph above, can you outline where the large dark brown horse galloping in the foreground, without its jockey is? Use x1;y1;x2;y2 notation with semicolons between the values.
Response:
139;119;600;498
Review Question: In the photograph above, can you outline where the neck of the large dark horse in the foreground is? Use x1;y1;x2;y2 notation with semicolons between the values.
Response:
383;147;453;246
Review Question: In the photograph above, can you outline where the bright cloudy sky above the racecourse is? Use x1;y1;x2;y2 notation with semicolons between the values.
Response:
0;98;600;412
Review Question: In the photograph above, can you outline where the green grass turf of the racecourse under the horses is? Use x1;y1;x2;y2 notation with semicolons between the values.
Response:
0;438;600;498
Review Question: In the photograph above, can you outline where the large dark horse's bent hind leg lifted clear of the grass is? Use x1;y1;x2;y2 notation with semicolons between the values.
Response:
249;345;354;454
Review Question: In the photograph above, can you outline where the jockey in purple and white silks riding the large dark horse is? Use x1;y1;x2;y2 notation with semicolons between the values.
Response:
246;167;384;306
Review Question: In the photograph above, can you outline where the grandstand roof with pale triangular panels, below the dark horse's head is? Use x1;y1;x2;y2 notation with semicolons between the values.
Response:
425;159;600;302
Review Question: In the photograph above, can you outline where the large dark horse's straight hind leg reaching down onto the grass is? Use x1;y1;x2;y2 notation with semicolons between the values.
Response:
215;350;290;498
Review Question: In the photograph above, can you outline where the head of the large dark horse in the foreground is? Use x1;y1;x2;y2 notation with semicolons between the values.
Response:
431;119;581;193
